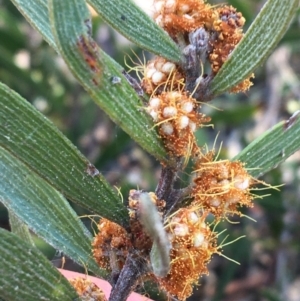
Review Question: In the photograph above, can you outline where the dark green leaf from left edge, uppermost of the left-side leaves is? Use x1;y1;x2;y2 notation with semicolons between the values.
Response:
0;83;128;224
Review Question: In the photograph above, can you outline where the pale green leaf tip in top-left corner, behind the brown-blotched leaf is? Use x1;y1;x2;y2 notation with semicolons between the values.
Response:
11;0;57;51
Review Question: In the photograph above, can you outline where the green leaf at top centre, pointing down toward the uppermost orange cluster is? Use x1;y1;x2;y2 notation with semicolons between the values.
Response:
88;0;181;63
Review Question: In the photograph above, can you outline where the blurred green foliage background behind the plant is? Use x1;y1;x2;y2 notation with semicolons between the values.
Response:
0;0;300;301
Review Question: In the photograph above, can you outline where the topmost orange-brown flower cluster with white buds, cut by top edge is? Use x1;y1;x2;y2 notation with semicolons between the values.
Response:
153;0;253;93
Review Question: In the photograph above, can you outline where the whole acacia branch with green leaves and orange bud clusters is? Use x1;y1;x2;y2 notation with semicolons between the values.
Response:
0;0;300;301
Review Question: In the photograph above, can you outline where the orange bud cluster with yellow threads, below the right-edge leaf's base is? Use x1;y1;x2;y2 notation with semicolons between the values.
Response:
191;152;255;219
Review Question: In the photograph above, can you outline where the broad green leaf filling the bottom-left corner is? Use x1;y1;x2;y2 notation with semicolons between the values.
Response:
0;229;78;301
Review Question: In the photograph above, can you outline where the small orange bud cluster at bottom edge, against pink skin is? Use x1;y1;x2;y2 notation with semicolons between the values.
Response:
69;278;107;301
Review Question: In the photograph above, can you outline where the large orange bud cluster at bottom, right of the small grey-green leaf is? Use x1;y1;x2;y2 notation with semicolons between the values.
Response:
157;206;218;300
